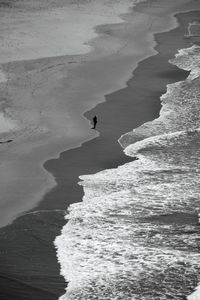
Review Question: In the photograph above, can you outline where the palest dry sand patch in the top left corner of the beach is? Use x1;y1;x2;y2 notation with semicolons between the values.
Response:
0;0;130;63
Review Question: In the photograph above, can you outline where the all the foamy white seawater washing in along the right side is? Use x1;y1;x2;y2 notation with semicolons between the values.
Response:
55;29;200;300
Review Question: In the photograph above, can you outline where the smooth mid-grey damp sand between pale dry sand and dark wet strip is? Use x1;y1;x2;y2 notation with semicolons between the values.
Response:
0;0;198;226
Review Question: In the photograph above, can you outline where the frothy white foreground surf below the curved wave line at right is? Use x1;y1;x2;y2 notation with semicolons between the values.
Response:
56;131;200;300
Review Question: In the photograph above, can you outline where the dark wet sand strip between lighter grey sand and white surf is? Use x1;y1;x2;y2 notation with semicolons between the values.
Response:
0;8;200;300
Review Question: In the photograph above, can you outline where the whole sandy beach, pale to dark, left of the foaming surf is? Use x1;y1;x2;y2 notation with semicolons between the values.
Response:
0;0;198;300
